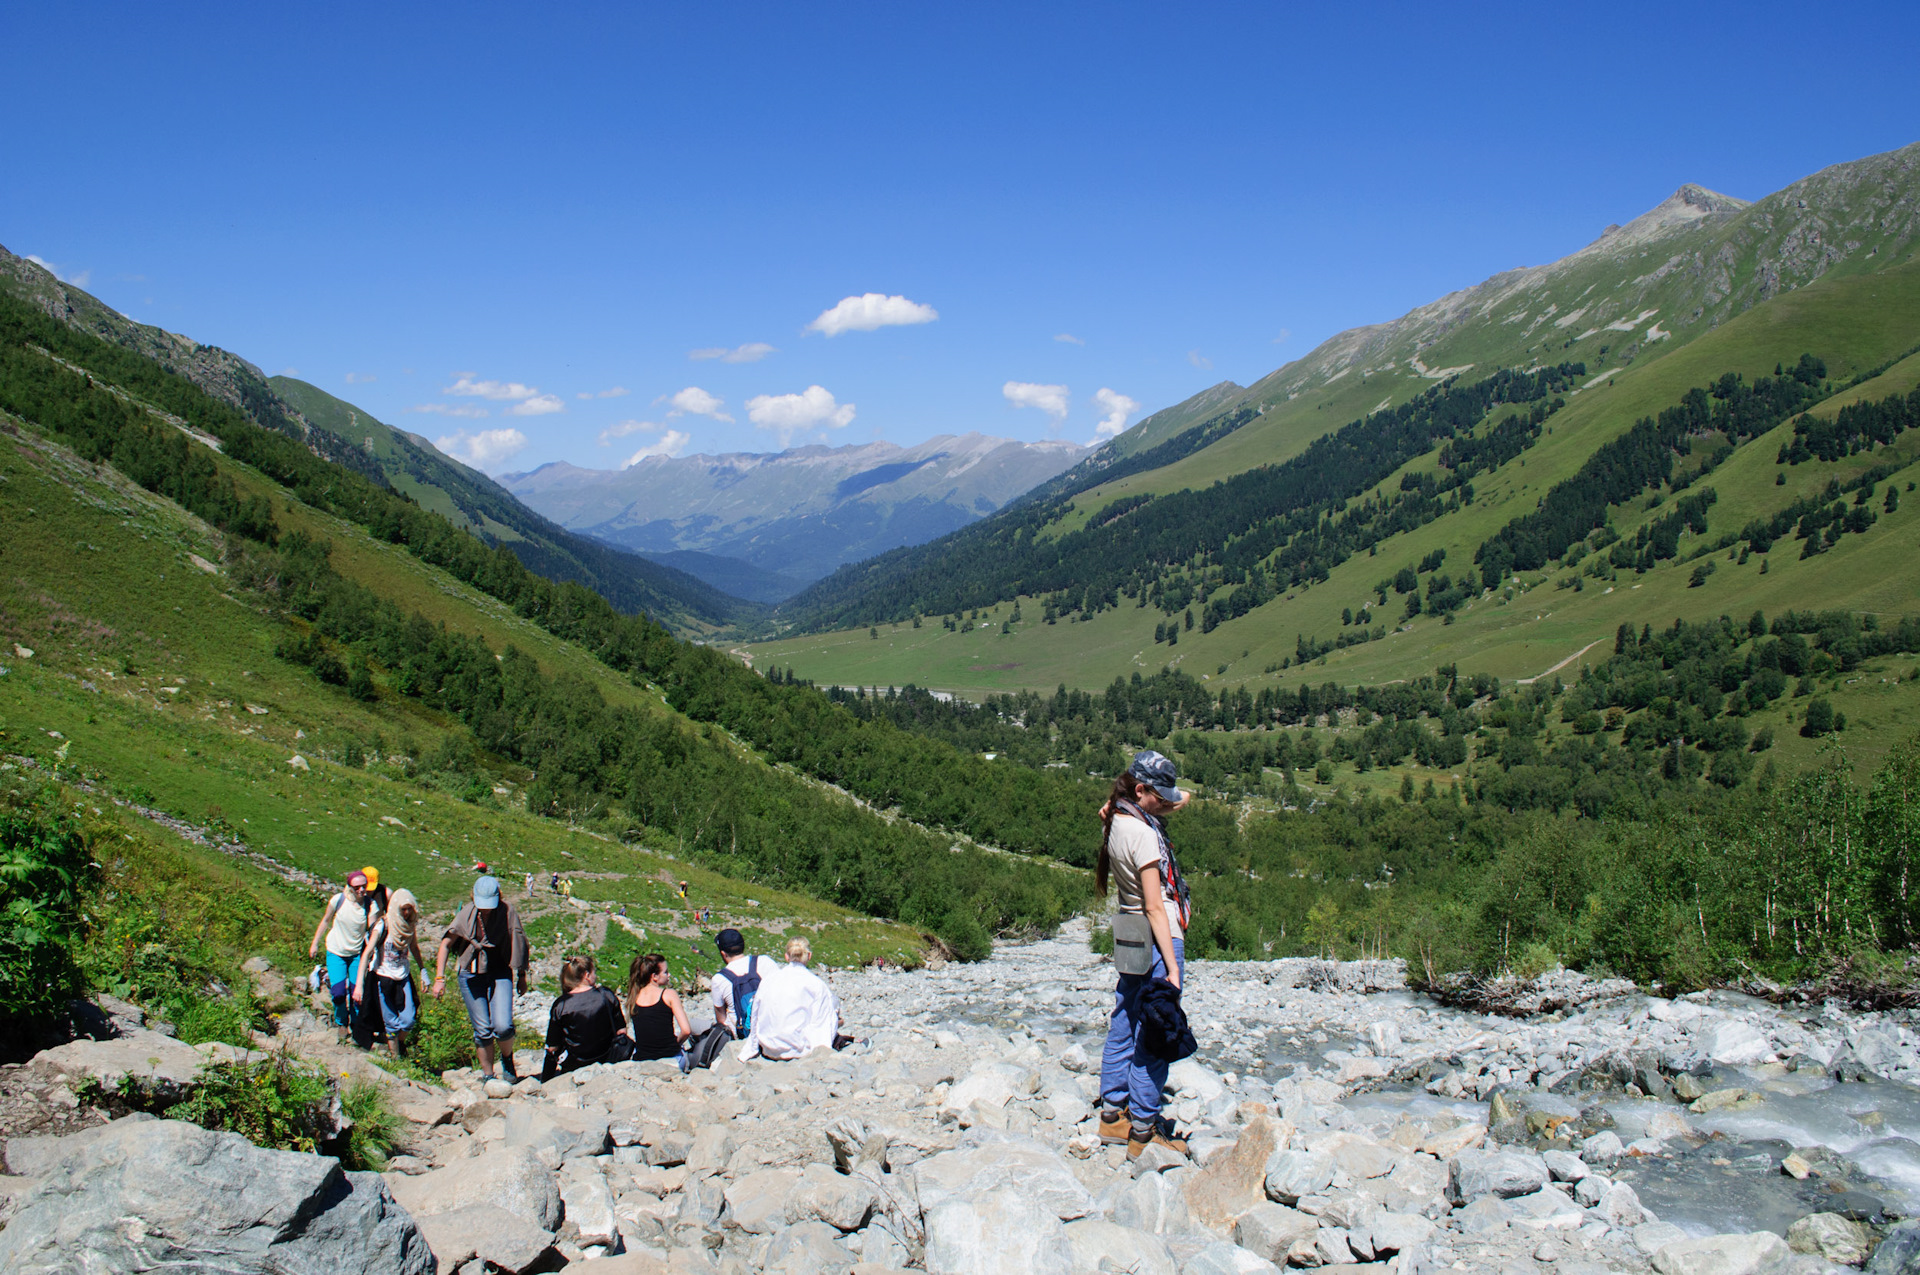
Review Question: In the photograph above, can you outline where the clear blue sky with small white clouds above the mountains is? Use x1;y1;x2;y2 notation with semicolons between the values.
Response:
0;4;1920;472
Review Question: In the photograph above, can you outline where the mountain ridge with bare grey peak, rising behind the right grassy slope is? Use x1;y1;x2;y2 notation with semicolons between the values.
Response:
764;137;1920;649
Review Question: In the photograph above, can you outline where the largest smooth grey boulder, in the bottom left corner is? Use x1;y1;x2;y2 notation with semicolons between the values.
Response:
0;1119;434;1275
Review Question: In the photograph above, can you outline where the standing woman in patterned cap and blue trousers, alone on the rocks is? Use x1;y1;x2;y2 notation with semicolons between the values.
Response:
1094;751;1190;1156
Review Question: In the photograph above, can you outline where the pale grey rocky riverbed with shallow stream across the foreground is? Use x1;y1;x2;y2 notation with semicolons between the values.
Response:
0;927;1920;1275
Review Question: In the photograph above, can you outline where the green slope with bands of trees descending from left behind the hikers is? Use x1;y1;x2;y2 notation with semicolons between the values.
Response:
0;288;1085;954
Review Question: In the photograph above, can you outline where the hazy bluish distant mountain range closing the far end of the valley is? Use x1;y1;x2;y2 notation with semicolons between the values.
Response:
501;434;1087;601
